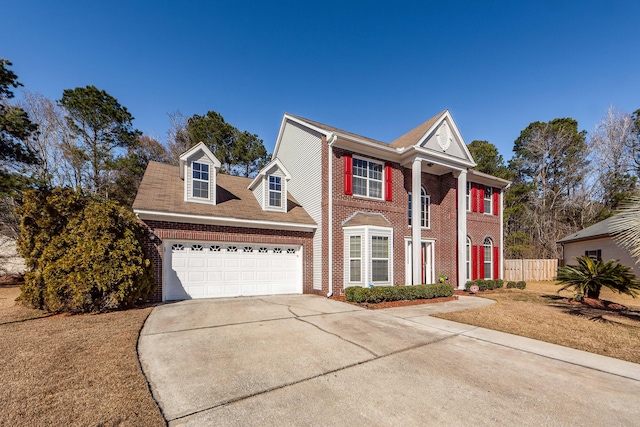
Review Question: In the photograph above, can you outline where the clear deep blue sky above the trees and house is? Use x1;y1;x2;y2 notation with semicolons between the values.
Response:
5;0;640;159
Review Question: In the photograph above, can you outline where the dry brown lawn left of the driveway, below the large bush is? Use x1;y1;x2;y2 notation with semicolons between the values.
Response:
0;286;166;426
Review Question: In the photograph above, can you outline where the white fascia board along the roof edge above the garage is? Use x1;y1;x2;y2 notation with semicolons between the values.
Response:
133;209;318;232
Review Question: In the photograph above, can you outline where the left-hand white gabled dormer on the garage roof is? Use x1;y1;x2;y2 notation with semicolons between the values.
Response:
180;142;220;205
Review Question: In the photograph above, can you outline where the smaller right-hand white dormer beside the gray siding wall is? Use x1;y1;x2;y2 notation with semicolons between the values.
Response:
248;159;291;212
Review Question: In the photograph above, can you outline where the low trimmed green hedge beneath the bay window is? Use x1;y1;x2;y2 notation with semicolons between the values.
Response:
344;283;453;304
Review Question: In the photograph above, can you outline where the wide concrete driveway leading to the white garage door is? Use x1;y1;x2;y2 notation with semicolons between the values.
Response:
138;295;640;426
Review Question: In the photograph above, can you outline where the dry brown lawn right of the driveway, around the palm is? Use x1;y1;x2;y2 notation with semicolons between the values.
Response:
437;282;640;363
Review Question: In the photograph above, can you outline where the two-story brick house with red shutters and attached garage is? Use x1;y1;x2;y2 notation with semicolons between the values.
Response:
133;110;509;300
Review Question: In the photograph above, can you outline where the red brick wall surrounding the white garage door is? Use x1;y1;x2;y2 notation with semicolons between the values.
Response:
142;221;317;301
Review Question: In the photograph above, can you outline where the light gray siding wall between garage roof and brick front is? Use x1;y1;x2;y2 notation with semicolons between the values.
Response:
276;122;323;289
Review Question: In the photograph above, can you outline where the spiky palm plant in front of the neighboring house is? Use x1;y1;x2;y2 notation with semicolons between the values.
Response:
556;256;640;299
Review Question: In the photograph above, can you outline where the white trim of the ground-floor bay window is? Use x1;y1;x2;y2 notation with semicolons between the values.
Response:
343;225;394;288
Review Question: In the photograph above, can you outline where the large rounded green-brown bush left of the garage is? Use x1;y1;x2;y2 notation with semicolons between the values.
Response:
18;188;155;313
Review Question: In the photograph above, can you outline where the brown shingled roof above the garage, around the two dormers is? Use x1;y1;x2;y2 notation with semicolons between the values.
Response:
133;161;316;228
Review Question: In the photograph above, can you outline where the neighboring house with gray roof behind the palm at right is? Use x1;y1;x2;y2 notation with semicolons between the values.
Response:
558;217;640;277
